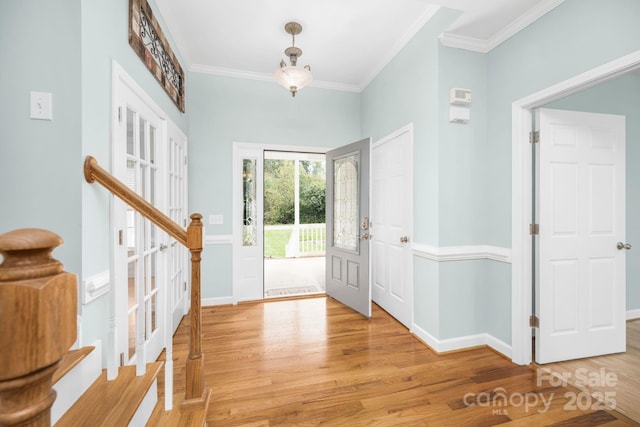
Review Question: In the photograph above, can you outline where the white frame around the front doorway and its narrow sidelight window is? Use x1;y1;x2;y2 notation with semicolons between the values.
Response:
231;142;330;305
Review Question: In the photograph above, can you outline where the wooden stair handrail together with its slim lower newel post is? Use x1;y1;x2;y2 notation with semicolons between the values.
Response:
84;156;209;407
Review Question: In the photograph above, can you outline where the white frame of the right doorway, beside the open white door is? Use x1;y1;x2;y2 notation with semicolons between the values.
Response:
511;50;640;365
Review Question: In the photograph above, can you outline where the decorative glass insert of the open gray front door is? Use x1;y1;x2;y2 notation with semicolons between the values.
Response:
333;153;360;252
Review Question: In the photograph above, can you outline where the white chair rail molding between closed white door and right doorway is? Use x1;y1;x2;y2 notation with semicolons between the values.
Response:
411;243;511;263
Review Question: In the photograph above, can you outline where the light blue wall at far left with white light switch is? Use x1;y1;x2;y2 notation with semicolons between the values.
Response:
0;0;82;274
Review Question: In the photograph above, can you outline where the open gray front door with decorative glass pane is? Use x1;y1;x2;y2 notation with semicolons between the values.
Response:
326;138;371;317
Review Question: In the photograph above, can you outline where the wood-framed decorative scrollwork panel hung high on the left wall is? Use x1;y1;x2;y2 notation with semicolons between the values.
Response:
129;0;184;113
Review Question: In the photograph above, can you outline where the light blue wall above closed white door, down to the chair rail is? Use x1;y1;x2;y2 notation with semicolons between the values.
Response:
362;9;459;245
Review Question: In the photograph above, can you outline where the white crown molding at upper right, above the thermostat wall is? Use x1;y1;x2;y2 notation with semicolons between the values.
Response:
440;0;564;53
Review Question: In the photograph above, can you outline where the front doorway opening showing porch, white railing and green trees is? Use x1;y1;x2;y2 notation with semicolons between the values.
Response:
263;151;326;298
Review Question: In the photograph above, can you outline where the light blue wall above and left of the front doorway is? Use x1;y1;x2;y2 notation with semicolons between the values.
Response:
187;72;360;298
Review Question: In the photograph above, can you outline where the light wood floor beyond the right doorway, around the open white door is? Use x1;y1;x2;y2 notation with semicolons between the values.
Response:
540;320;640;422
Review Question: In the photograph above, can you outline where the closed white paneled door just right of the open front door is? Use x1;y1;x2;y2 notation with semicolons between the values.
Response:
370;127;413;328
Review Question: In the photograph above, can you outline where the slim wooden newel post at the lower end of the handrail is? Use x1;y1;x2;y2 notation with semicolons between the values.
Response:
184;213;208;405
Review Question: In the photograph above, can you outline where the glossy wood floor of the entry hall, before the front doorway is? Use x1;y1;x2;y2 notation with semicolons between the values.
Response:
168;296;638;427
